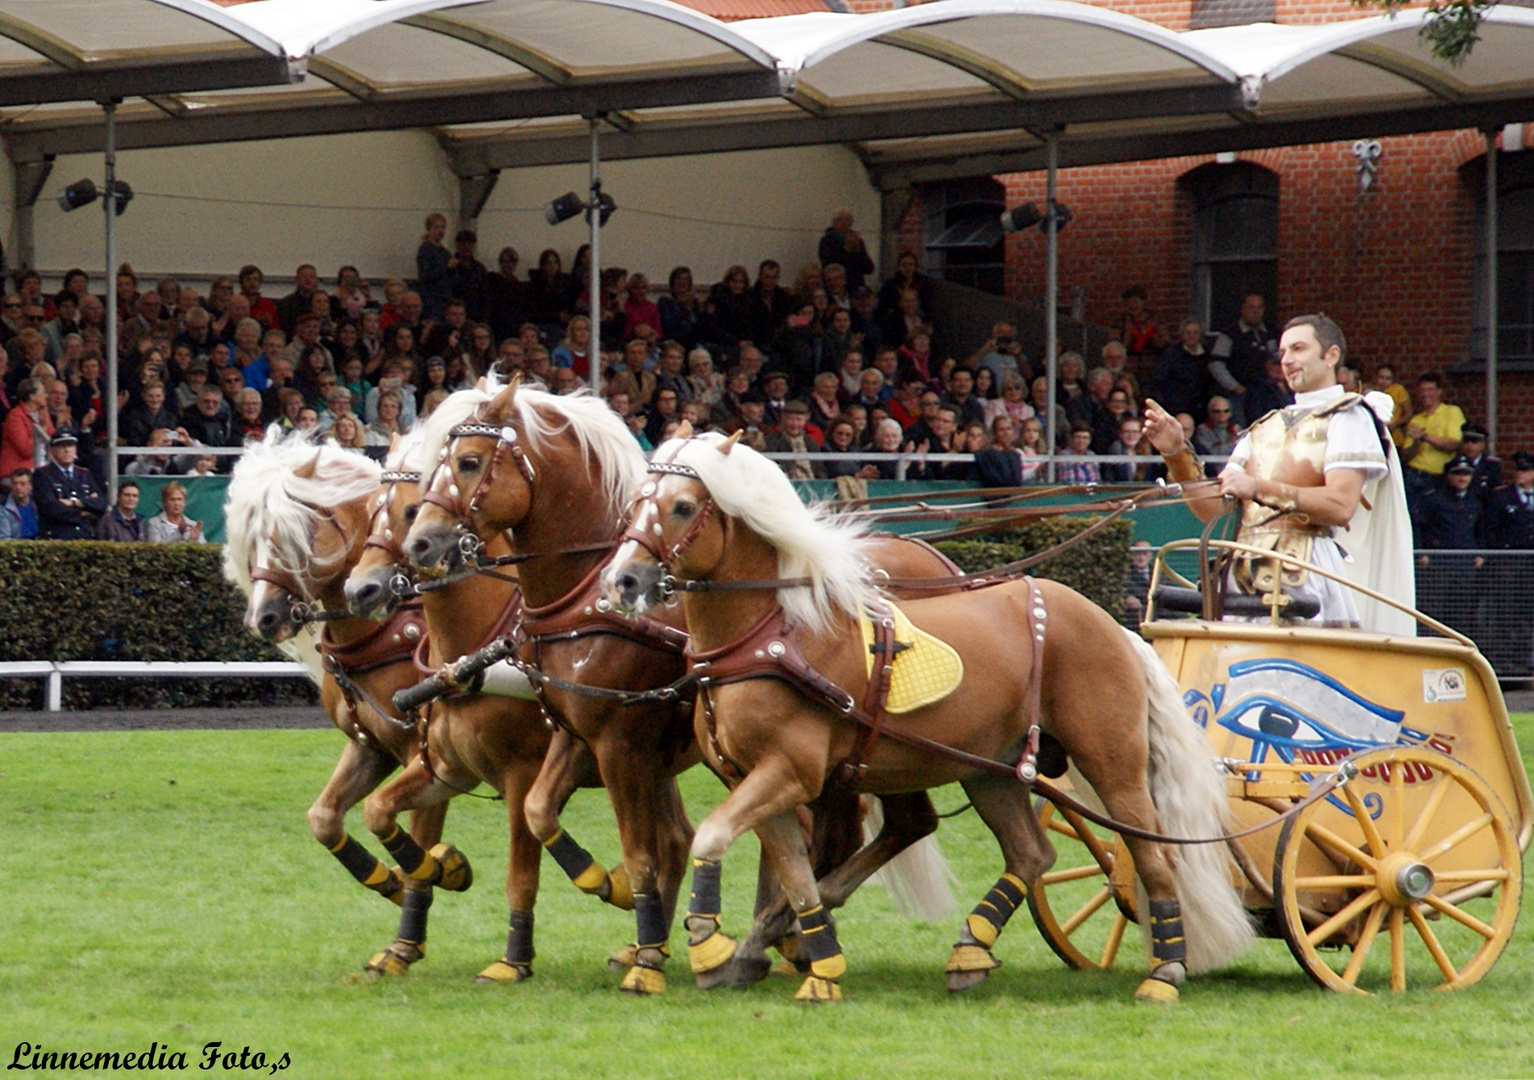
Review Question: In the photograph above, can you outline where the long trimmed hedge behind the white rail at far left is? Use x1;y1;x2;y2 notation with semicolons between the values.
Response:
0;540;318;709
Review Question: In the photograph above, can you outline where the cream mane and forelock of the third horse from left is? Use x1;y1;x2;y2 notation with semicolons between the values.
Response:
420;382;644;514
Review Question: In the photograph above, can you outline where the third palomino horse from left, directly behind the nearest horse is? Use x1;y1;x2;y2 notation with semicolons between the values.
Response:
403;385;950;993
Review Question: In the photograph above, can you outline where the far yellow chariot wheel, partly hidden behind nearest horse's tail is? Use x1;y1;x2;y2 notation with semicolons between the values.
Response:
1028;799;1137;970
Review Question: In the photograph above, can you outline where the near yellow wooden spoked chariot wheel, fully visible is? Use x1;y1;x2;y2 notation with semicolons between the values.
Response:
1273;747;1523;994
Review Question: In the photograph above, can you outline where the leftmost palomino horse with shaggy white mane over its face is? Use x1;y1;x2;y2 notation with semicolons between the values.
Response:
224;439;471;974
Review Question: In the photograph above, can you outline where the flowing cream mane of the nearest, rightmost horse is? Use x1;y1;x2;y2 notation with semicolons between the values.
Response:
655;433;879;634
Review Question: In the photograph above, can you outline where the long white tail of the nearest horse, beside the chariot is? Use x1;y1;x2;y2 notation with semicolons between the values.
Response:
1124;629;1256;973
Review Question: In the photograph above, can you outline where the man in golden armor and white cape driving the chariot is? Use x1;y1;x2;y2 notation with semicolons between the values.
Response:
1144;314;1416;635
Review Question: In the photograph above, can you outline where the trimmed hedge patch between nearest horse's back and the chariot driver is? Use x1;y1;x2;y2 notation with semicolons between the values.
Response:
936;517;1134;618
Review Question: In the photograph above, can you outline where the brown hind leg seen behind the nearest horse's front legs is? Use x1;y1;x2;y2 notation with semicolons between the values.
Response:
711;792;937;988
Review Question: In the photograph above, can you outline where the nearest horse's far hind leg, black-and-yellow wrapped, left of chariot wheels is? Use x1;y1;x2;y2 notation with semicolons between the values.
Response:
945;773;1055;993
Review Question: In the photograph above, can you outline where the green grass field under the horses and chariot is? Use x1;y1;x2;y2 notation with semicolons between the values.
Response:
0;715;1534;1080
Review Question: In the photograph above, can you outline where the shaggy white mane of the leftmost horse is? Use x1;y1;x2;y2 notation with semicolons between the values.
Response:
224;433;382;597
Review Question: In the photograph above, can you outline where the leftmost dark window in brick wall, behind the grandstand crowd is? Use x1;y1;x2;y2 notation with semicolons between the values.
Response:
922;176;1006;296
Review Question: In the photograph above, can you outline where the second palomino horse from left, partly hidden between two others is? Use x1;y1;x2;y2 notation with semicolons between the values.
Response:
345;428;616;982
